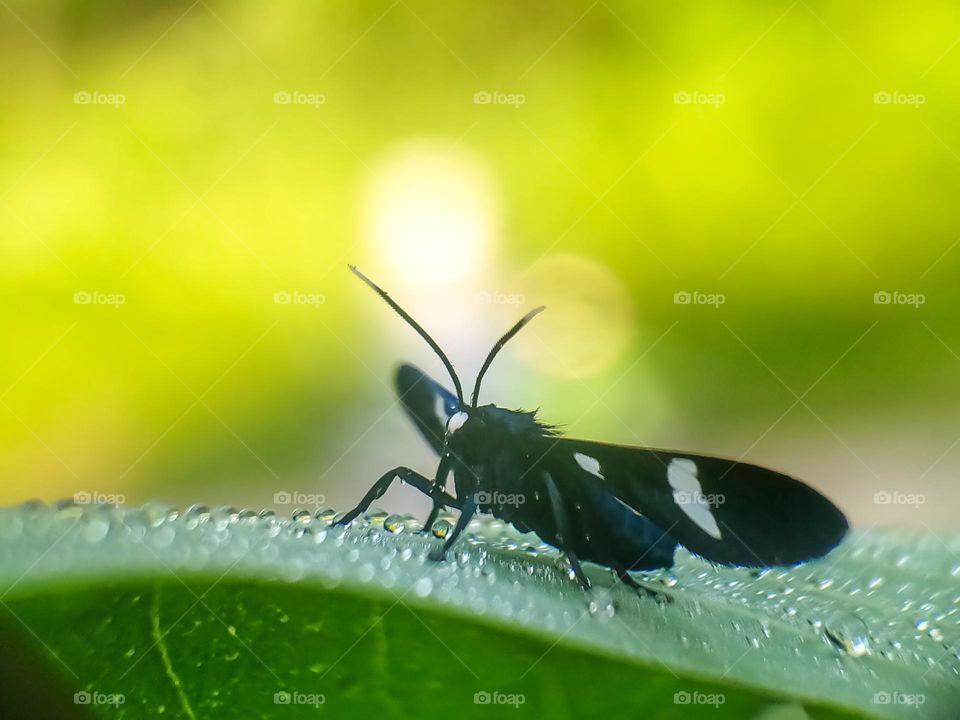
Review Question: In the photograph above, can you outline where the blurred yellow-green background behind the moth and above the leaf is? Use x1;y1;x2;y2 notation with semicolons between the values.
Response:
0;0;960;528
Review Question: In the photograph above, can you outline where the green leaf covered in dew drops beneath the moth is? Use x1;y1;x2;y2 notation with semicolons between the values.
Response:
0;503;960;720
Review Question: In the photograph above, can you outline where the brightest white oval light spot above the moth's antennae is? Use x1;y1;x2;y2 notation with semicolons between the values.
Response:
363;139;497;287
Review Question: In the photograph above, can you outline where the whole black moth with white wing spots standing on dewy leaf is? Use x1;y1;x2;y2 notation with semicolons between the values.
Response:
339;265;848;594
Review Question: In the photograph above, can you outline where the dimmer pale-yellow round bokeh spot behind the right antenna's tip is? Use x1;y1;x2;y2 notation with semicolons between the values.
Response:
518;255;634;378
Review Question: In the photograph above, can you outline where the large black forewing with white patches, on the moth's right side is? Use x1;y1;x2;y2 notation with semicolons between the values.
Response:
551;439;849;567
